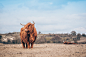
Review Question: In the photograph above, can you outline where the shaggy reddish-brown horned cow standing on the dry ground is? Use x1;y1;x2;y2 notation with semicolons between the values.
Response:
20;23;37;48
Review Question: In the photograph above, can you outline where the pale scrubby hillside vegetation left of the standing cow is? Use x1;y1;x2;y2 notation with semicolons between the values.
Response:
0;32;21;44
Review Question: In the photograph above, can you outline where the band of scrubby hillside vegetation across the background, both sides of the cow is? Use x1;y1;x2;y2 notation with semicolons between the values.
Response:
0;31;86;44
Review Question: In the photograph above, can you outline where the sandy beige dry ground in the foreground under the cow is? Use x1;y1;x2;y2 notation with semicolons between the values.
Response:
0;43;86;57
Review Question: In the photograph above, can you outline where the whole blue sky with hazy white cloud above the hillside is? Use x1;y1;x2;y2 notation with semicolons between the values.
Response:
0;0;86;33
